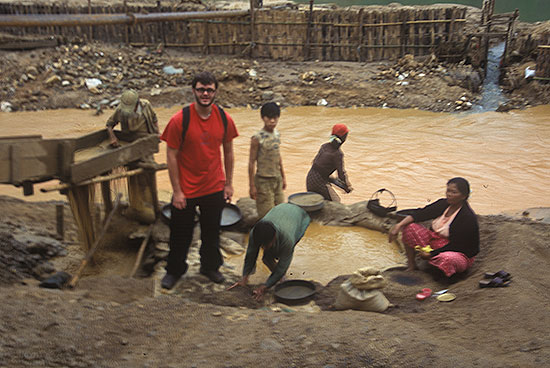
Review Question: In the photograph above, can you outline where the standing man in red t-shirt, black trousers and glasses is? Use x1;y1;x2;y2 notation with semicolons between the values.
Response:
161;72;239;289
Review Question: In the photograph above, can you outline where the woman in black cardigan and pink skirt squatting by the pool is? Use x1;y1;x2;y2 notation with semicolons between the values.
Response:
389;178;479;277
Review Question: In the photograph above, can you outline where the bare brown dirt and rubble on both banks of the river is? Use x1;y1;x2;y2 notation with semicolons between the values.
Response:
0;1;550;368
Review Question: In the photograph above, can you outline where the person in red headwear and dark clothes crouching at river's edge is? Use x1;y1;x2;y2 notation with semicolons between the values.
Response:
306;124;353;202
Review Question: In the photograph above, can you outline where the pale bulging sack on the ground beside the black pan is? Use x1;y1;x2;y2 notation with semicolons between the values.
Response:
334;280;390;312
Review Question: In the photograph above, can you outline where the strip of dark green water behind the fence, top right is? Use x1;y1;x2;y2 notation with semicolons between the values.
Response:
297;0;550;23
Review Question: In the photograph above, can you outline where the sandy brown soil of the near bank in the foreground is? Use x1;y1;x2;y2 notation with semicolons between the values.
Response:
0;197;550;367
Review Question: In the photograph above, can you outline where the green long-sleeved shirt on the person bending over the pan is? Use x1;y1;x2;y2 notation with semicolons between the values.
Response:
243;203;311;288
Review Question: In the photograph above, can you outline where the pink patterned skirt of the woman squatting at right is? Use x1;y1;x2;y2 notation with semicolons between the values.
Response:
403;223;475;277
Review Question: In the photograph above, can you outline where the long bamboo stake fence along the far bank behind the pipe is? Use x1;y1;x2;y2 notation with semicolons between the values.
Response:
0;3;472;61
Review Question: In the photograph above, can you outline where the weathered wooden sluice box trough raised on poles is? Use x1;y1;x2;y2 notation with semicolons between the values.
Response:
0;129;159;195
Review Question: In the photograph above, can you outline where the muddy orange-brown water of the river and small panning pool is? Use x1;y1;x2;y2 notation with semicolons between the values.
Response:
0;105;550;282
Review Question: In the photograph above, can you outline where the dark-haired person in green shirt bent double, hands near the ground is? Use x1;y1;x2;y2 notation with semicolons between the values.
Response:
228;203;311;300
